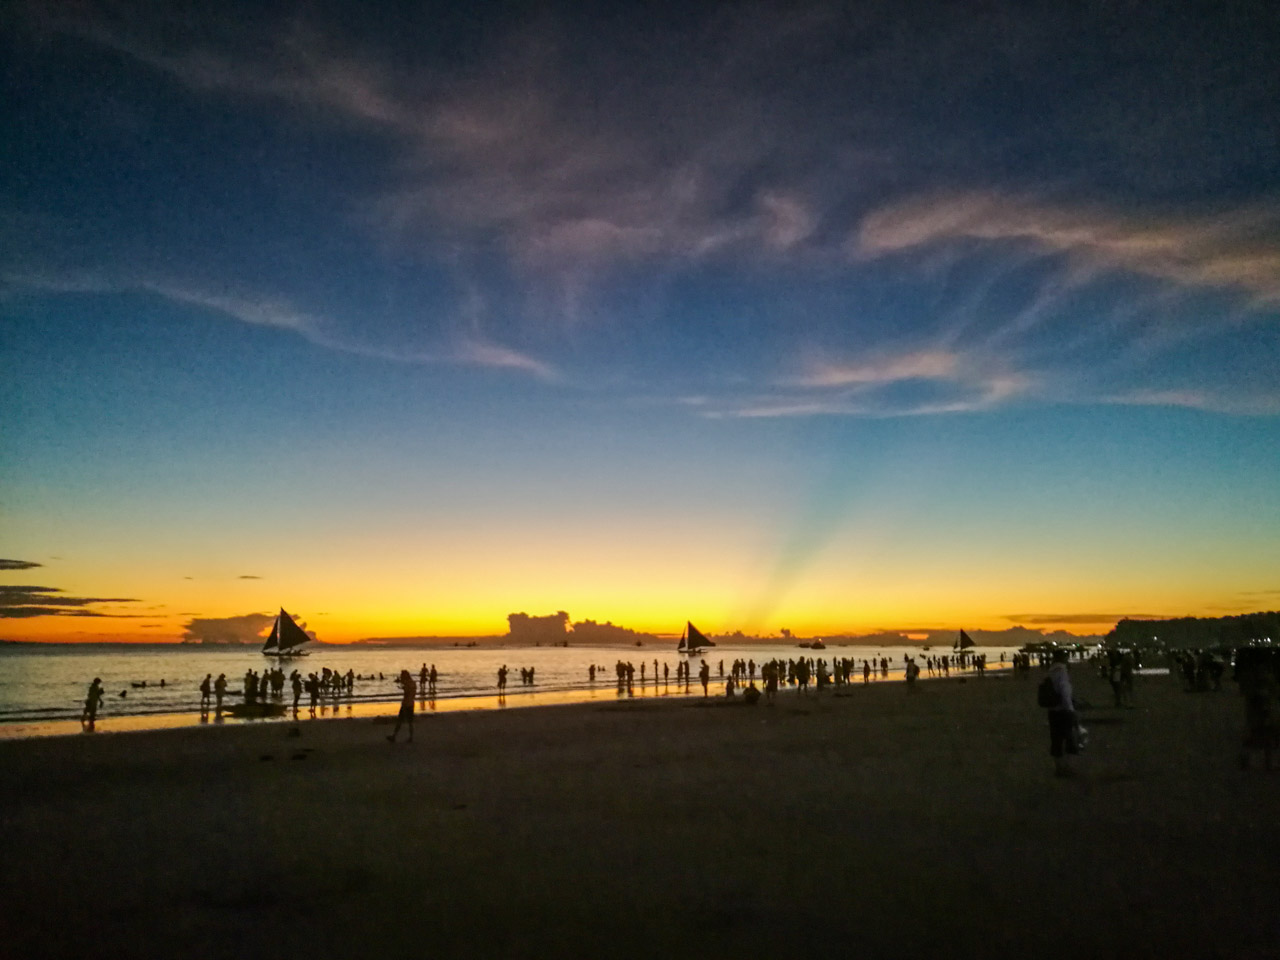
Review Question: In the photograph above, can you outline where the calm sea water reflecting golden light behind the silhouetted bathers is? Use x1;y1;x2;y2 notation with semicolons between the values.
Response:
0;644;1012;724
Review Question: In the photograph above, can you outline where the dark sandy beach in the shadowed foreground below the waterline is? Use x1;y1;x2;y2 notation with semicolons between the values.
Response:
0;668;1280;960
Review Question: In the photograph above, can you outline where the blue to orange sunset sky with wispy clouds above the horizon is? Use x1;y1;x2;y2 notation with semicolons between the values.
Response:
0;0;1280;641
